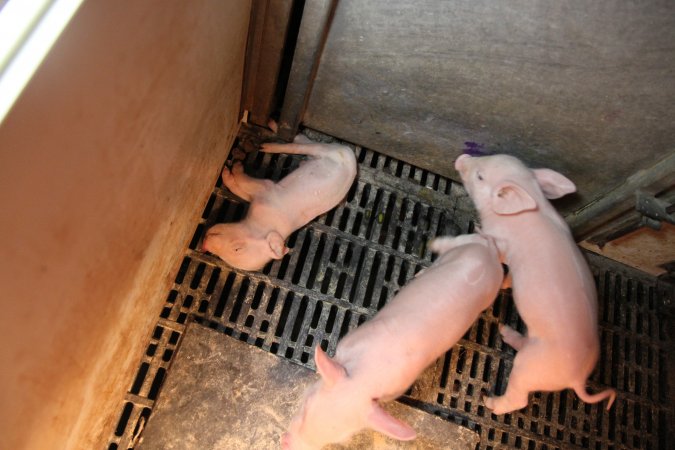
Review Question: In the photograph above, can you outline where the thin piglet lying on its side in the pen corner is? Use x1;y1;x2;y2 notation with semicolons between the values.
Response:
202;135;356;270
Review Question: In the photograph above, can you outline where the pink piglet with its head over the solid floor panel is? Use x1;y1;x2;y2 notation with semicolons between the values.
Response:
281;234;503;450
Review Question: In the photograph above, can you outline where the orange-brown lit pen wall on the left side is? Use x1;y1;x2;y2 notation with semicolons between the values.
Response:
0;0;250;449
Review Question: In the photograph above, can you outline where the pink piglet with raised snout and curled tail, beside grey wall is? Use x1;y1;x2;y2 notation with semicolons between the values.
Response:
455;155;616;414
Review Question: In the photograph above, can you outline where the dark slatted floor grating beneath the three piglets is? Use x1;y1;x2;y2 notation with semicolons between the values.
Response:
109;125;673;450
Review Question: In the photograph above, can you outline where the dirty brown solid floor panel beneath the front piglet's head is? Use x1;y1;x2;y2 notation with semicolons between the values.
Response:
140;323;478;450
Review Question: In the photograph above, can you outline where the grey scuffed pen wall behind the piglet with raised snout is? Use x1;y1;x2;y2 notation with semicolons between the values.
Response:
304;0;675;214
